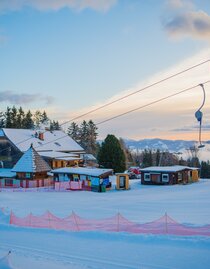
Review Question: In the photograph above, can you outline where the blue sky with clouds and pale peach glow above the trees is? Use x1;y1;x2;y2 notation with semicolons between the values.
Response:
0;0;210;140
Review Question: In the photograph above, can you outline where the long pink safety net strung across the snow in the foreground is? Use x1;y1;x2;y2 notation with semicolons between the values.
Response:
10;211;210;236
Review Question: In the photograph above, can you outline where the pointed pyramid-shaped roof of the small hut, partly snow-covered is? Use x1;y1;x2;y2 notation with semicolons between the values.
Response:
12;146;51;173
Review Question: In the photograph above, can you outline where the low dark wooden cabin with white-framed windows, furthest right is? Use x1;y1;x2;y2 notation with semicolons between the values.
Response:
141;165;199;185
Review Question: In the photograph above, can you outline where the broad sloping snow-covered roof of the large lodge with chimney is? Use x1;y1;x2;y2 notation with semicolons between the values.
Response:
3;128;84;152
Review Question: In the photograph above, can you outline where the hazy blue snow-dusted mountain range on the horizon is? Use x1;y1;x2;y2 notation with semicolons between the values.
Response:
123;138;210;161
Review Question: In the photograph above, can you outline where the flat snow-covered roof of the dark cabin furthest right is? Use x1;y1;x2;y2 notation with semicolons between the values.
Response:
140;165;199;172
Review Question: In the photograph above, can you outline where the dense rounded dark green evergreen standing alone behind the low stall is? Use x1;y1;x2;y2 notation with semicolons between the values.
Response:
98;135;126;173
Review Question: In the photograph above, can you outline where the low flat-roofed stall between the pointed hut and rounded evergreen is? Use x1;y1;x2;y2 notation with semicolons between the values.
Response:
52;167;113;192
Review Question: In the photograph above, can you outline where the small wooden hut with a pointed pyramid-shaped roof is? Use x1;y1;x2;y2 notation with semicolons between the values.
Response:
12;145;51;188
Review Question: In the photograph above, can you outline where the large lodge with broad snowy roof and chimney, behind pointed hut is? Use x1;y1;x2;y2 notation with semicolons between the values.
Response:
0;128;85;169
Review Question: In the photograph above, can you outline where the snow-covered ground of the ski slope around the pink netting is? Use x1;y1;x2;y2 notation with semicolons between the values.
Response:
0;180;210;269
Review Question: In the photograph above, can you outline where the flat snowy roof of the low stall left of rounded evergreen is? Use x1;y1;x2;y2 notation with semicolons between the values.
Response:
52;167;113;177
